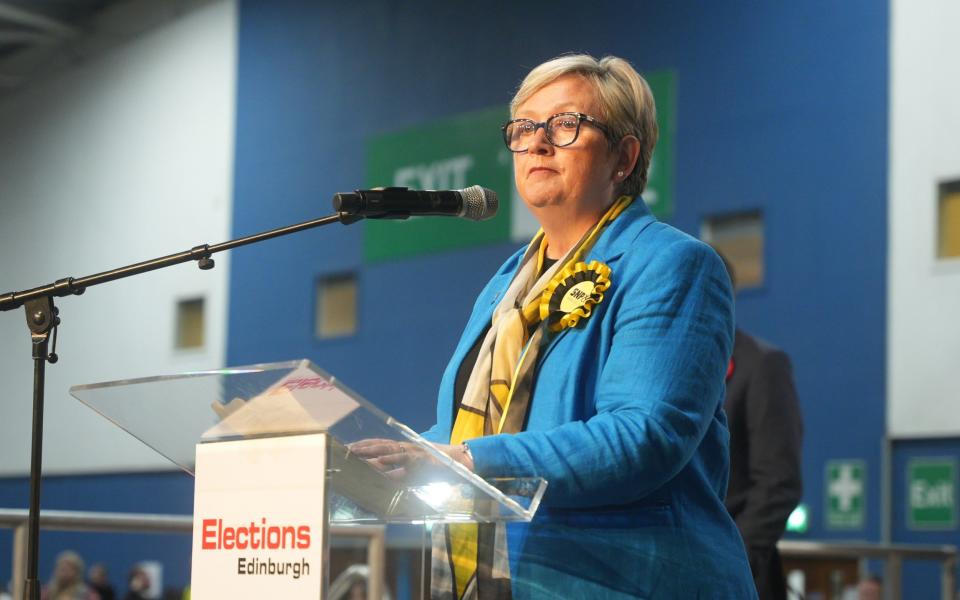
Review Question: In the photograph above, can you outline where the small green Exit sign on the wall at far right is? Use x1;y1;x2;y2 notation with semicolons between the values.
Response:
907;458;957;530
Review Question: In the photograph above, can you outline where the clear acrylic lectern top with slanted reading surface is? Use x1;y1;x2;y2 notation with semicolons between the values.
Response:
70;360;546;596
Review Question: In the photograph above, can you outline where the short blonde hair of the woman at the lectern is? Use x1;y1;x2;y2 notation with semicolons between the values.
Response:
510;54;659;196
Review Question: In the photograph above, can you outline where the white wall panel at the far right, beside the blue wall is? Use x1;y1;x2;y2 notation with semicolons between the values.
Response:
887;0;960;436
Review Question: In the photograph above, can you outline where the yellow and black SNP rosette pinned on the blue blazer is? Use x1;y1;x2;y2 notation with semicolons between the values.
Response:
540;260;610;331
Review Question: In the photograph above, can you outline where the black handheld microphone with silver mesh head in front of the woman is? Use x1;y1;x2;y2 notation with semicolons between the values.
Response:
333;185;499;221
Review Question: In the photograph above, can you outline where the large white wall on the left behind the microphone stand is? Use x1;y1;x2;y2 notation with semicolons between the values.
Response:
0;0;236;475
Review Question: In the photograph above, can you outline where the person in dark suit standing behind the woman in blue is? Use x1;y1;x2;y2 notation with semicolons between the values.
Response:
724;266;803;600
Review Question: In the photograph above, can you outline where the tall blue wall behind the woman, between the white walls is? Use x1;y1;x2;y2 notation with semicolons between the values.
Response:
228;0;888;540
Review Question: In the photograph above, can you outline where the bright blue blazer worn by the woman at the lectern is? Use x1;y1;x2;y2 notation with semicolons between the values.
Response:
424;203;756;599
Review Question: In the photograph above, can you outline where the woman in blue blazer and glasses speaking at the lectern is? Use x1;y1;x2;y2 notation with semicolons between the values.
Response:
366;55;756;599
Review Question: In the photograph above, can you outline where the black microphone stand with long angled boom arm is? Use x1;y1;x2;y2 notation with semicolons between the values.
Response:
0;212;363;600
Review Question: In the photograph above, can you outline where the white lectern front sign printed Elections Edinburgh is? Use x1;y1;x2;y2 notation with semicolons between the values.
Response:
190;433;327;600
